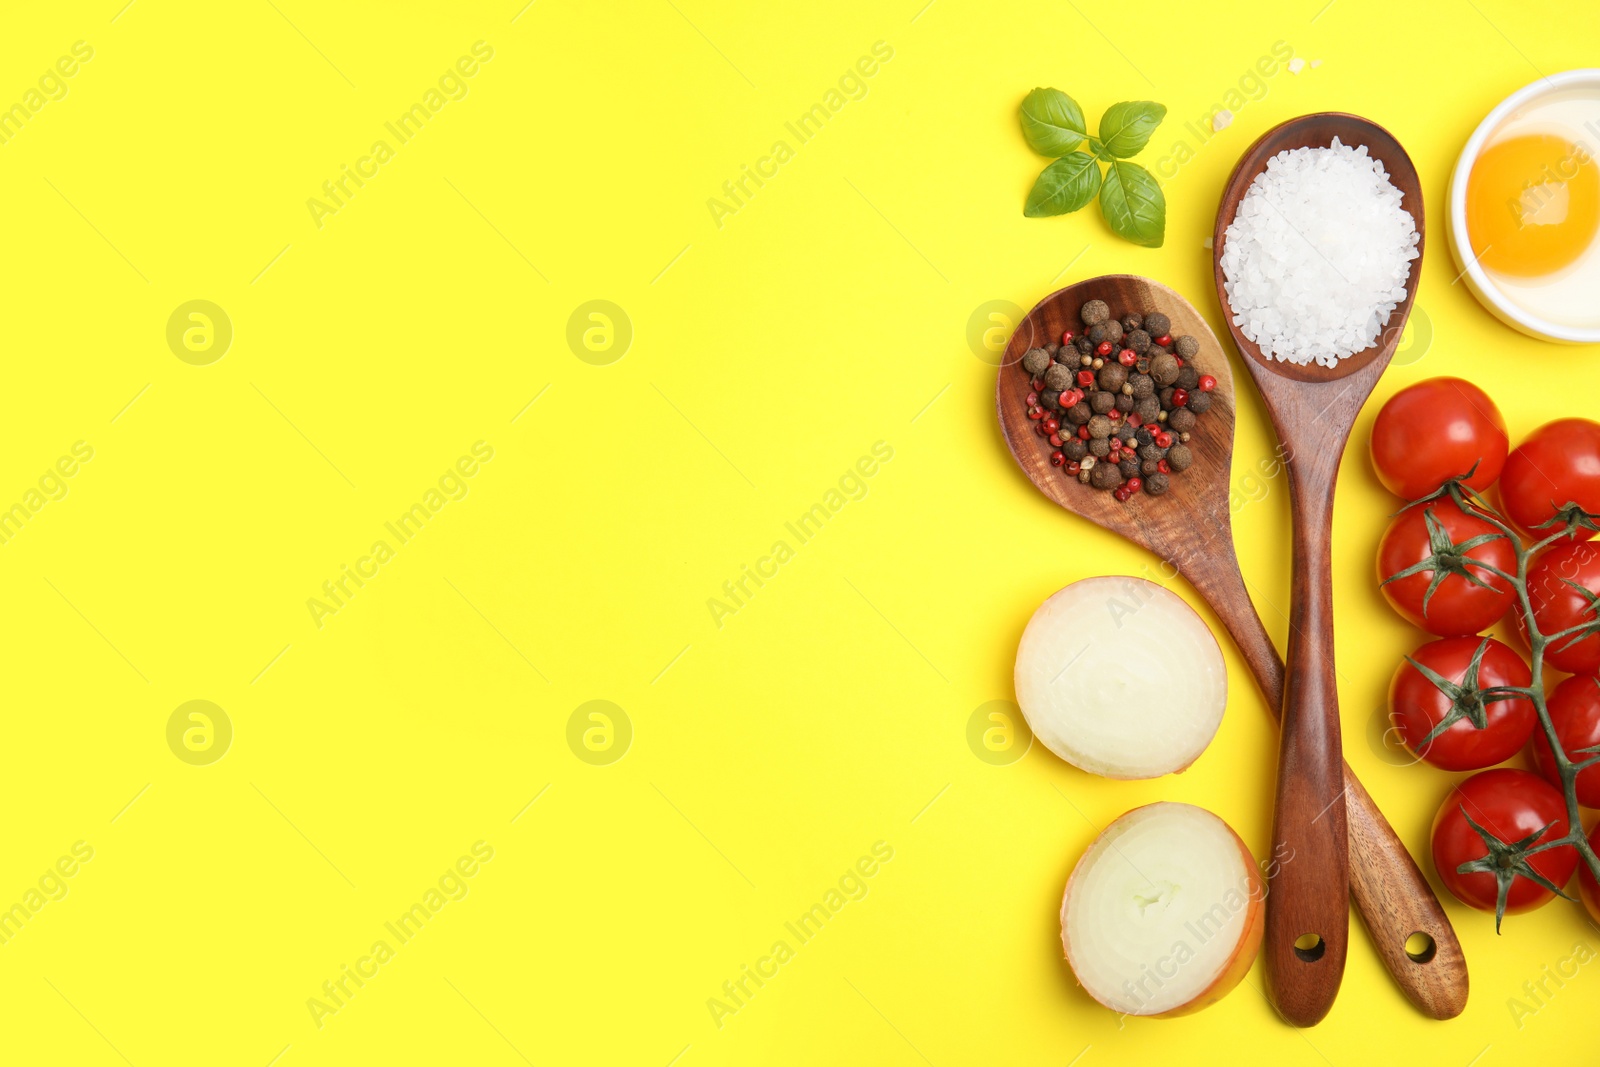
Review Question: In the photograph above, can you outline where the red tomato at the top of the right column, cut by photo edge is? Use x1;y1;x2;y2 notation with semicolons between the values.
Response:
1501;419;1600;541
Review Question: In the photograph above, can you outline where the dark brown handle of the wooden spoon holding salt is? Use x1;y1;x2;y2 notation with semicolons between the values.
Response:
1262;476;1350;1025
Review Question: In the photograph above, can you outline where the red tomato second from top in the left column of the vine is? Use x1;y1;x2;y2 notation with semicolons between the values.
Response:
1378;501;1517;637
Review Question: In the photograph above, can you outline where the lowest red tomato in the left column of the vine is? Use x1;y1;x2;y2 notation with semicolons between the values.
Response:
1432;768;1578;926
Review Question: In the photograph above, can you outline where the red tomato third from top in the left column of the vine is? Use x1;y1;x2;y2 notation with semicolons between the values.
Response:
1389;637;1536;771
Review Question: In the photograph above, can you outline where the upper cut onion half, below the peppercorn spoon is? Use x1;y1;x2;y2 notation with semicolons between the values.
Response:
1016;577;1227;777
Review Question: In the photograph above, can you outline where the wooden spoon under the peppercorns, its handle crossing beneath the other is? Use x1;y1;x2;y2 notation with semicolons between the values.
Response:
997;274;1467;1019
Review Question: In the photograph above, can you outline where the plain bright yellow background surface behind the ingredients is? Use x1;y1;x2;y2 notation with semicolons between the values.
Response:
0;0;1600;1067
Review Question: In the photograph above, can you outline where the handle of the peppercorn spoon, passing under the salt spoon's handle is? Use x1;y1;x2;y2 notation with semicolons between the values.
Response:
1174;537;1469;1019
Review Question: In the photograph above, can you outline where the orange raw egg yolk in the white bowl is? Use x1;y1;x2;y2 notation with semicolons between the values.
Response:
1467;133;1600;278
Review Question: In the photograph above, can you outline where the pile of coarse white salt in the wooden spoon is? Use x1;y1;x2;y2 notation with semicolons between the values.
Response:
1222;138;1418;366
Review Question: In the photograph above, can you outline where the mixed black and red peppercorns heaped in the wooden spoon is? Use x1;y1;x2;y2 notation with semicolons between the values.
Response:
1022;301;1216;501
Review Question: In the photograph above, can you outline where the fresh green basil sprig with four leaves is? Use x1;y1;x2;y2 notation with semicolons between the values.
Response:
1021;88;1166;248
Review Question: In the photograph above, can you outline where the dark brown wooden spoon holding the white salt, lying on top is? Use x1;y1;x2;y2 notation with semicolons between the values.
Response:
1211;112;1438;1025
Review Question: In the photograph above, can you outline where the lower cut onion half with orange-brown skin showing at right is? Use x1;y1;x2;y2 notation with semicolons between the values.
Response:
1061;801;1266;1016
